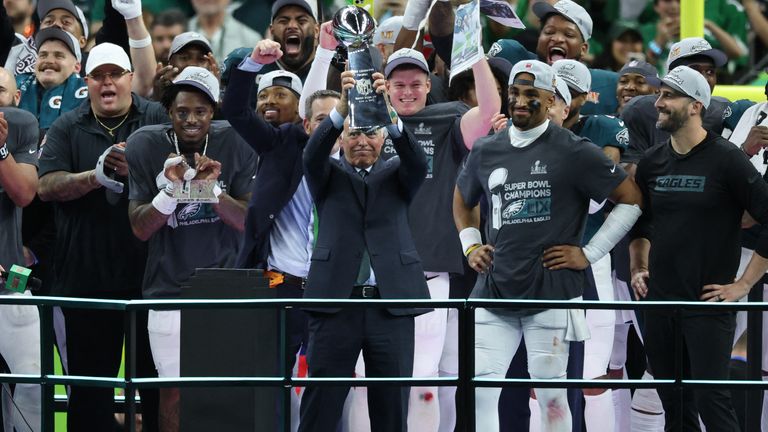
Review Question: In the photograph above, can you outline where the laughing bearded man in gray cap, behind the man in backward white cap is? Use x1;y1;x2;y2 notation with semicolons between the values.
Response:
488;0;617;114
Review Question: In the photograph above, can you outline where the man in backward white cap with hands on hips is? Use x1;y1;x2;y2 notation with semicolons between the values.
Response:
453;60;641;431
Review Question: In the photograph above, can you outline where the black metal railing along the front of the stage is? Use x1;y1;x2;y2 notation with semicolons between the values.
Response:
0;296;768;432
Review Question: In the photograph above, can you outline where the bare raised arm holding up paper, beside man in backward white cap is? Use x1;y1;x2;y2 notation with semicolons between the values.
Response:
461;58;501;150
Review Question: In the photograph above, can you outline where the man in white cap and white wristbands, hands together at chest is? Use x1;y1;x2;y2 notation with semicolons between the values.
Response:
126;66;256;432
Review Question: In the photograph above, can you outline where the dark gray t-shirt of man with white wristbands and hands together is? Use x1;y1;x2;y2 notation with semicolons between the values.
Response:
125;121;256;298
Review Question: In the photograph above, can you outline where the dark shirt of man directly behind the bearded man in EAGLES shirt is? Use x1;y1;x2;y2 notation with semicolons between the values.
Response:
621;95;730;163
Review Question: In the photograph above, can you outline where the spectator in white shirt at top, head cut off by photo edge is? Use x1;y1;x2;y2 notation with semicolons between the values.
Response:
189;0;261;63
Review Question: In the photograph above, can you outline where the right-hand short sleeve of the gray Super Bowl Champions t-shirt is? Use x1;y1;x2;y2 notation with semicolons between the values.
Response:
573;140;627;202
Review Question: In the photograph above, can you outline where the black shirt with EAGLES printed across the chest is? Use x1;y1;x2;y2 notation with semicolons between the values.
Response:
632;132;768;313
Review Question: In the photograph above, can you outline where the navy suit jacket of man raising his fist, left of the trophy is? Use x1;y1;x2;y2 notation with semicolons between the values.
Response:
221;67;308;269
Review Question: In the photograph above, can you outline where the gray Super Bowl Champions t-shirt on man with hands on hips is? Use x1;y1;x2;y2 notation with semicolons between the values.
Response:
457;123;626;300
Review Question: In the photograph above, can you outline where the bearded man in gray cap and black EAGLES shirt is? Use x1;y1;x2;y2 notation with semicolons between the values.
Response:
630;66;768;431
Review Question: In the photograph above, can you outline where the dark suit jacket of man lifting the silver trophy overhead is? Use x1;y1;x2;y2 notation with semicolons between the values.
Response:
304;116;429;315
